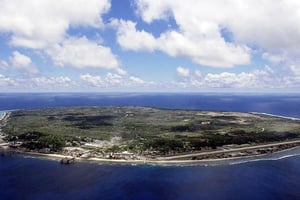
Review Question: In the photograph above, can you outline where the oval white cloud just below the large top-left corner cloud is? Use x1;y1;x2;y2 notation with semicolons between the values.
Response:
47;37;119;72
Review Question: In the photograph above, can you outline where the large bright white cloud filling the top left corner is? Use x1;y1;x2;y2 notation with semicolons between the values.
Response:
0;0;110;49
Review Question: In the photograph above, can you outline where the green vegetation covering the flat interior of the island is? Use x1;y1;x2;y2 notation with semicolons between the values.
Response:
3;107;300;154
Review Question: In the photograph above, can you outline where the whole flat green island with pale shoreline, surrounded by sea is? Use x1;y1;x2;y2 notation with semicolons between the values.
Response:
0;106;300;163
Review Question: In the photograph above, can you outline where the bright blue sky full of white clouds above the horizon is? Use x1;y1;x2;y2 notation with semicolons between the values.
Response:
0;0;300;93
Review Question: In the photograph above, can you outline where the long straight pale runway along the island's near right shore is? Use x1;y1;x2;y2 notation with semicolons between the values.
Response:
156;140;300;160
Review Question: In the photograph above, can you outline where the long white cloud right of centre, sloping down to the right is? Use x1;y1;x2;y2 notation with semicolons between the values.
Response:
113;21;250;67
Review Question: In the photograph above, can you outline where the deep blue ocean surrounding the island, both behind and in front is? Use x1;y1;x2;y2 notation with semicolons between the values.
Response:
0;93;300;200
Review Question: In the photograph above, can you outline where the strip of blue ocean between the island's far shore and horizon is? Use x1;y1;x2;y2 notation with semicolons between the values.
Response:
0;93;300;117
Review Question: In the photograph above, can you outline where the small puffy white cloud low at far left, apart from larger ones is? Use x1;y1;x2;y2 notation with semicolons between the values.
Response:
6;51;39;74
